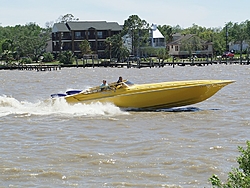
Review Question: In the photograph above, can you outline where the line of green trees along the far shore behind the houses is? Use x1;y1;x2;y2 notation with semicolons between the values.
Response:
0;14;250;64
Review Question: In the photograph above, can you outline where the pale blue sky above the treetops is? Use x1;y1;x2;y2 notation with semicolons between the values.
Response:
0;0;250;28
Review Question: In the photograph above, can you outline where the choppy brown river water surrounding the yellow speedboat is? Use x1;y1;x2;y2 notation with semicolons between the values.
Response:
0;65;250;188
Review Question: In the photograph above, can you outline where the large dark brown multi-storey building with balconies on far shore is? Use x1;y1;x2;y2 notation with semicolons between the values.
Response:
52;21;122;58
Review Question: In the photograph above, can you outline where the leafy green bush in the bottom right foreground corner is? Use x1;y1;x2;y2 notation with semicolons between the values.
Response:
209;141;250;188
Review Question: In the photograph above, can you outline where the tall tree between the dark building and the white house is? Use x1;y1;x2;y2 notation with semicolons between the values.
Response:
122;15;150;56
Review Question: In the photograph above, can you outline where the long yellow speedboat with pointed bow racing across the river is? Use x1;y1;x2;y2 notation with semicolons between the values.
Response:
51;80;235;109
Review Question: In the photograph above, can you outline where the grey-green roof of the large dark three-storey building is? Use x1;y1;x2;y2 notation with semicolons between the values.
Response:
53;21;122;32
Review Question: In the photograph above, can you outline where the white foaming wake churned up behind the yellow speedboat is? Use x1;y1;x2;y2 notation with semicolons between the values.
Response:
0;95;129;117
